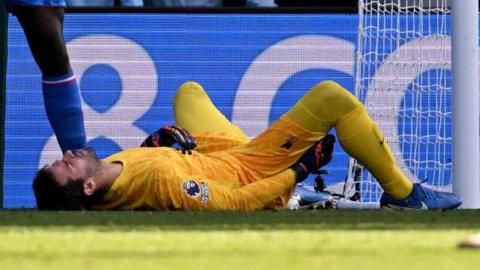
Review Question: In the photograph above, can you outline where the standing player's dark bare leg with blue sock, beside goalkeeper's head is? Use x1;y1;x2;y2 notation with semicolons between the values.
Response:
12;4;86;152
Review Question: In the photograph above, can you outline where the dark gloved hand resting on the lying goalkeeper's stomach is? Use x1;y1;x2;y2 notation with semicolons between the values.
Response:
140;125;197;151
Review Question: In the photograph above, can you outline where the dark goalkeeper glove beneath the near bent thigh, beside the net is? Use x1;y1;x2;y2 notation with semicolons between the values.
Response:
290;134;335;183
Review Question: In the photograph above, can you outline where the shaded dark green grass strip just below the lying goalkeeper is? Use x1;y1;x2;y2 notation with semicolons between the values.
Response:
0;210;480;230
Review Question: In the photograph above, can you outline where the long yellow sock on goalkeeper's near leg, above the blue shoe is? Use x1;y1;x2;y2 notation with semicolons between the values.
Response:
287;81;413;199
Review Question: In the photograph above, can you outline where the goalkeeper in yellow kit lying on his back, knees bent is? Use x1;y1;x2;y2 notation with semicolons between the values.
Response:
33;81;461;210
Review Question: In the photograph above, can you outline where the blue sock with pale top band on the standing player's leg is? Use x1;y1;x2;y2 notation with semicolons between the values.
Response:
42;72;86;152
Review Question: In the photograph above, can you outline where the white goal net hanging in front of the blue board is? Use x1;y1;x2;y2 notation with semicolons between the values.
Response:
356;0;452;202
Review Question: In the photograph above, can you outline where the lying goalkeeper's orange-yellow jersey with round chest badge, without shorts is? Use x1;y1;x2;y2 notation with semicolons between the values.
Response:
94;147;295;210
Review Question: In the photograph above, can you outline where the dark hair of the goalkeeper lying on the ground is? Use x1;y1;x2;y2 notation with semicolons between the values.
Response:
33;168;90;210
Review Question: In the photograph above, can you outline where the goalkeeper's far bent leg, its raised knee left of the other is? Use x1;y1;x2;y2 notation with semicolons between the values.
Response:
173;82;249;153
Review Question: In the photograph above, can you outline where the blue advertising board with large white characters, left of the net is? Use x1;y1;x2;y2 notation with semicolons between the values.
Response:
4;14;450;208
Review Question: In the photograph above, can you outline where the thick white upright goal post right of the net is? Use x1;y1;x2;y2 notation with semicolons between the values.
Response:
452;0;480;208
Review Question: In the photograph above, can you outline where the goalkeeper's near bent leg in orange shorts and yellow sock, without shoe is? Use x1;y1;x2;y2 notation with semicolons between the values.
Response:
227;81;412;198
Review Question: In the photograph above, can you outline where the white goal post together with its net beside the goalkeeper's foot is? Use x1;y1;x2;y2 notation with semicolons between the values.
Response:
355;0;480;208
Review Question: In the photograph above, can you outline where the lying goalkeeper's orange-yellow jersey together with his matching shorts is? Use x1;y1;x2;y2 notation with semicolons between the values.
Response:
94;117;323;210
